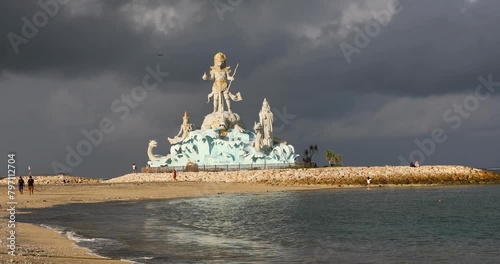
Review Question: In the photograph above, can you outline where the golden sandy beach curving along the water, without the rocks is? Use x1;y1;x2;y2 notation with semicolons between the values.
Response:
0;182;324;264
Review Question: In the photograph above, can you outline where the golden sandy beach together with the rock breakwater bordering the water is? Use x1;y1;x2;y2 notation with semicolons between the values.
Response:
0;166;500;263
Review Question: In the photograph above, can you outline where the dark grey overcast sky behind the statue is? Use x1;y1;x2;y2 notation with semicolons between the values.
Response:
0;0;500;178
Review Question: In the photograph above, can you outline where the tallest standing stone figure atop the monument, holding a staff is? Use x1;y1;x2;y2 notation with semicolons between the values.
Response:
201;52;242;112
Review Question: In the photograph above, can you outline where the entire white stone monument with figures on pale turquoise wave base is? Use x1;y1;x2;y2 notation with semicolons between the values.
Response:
148;52;298;168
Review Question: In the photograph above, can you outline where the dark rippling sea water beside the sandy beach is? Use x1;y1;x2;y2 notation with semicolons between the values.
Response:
23;185;500;263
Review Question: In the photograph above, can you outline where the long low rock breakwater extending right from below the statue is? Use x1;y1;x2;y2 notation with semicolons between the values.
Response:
106;166;500;186
